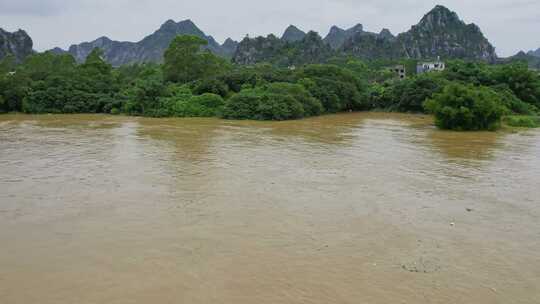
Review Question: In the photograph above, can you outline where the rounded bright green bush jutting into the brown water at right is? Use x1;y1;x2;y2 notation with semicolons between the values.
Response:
425;84;504;131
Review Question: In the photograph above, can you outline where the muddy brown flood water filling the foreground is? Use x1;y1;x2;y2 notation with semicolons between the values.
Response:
0;113;540;304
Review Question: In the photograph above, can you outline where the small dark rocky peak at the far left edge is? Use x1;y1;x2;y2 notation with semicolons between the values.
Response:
0;28;33;62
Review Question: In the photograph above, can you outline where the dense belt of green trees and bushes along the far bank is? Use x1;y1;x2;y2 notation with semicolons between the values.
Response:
0;36;540;130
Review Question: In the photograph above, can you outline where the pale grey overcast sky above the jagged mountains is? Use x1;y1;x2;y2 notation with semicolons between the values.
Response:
0;0;540;56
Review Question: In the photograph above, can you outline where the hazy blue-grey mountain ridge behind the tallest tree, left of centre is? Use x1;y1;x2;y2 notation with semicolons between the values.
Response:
51;20;235;66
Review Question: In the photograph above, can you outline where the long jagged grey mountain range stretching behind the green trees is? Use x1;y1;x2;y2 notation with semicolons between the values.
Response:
0;5;500;66
